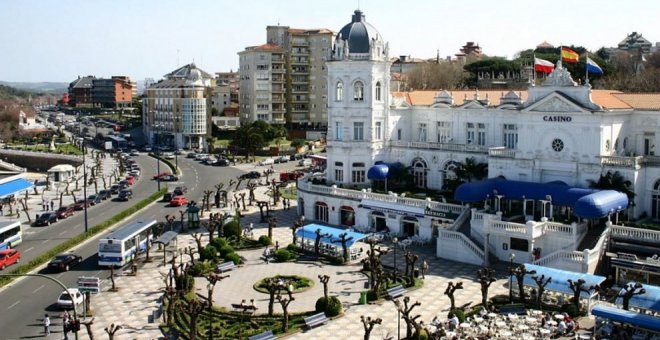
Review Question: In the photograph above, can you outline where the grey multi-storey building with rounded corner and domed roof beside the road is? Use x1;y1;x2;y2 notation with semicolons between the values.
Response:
142;64;215;150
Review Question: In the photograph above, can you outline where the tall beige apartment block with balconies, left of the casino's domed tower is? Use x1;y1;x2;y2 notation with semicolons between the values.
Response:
238;26;334;128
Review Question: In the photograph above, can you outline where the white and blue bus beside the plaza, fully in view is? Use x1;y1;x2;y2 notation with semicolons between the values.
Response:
99;220;157;267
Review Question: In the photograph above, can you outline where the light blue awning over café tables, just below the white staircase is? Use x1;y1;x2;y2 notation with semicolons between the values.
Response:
513;263;605;298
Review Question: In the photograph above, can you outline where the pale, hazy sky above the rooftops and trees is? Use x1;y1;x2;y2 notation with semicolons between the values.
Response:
0;0;660;82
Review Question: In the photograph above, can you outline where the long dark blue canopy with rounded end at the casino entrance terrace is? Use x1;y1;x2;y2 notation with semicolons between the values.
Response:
455;177;628;218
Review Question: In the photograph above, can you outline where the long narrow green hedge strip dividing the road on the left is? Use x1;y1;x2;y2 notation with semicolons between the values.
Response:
0;188;167;287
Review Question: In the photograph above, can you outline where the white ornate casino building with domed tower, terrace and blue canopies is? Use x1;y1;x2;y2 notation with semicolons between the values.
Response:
298;10;660;272
